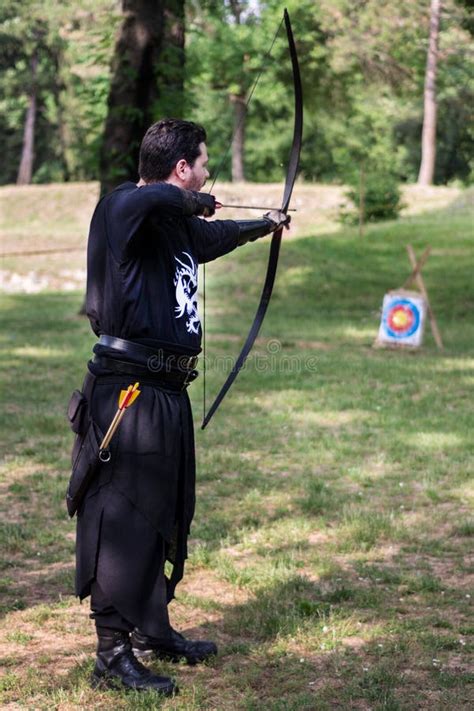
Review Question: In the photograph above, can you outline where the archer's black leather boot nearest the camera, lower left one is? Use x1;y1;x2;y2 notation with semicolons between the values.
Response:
92;628;178;696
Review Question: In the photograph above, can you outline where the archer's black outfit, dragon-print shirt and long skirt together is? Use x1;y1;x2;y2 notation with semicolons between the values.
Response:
76;183;286;637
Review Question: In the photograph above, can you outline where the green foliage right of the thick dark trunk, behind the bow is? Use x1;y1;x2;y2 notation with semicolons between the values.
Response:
188;0;474;183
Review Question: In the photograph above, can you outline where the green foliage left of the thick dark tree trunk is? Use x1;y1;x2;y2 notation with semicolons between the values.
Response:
0;0;116;183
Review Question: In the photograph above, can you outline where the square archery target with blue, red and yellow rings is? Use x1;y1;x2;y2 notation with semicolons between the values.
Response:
377;291;426;347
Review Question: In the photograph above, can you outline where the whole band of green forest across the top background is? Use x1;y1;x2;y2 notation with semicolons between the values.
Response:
0;0;474;193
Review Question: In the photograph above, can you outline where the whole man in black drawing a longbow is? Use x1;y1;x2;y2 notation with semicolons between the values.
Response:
70;119;289;695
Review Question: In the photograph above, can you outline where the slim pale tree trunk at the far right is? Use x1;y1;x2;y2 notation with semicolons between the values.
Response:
418;0;441;185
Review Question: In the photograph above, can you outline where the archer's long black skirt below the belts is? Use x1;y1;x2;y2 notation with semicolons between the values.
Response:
76;375;195;636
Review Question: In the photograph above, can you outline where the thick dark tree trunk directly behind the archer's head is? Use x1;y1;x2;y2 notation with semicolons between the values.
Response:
100;0;184;194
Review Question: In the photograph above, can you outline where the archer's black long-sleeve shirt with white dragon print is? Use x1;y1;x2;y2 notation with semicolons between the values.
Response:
86;182;239;354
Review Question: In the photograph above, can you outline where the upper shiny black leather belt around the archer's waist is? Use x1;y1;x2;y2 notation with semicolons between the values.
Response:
99;334;198;374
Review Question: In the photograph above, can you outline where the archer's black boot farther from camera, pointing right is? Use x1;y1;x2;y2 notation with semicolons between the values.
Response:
131;628;217;664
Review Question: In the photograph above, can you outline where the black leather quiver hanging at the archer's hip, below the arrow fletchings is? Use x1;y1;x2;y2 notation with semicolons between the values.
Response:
66;420;104;518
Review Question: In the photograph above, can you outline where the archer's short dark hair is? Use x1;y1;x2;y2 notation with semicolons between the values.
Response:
138;119;207;182
